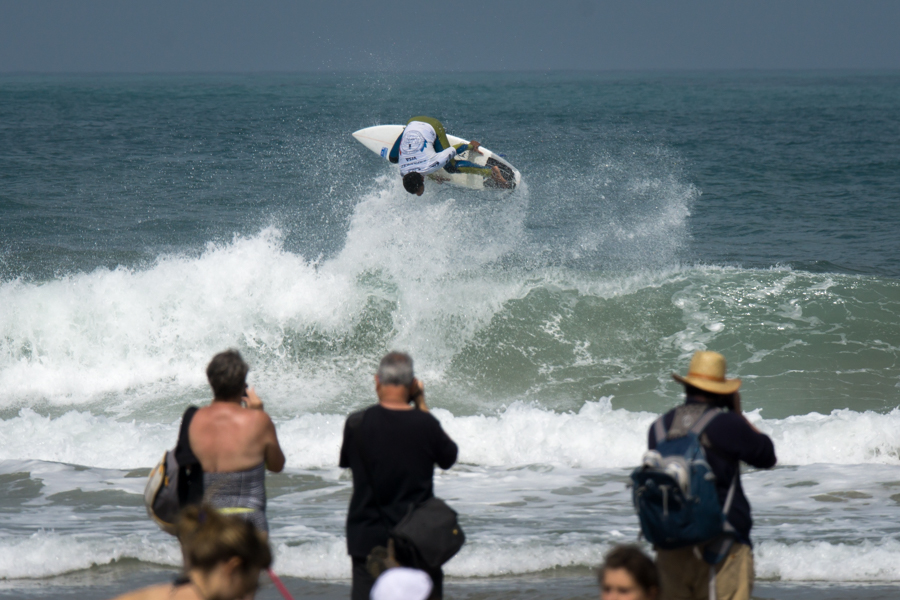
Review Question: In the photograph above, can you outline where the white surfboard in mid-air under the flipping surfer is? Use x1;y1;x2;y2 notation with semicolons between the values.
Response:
353;125;522;190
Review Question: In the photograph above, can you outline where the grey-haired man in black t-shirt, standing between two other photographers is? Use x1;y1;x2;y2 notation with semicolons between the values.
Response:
340;352;458;600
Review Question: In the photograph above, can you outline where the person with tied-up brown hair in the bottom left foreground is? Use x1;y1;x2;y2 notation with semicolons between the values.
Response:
116;505;272;600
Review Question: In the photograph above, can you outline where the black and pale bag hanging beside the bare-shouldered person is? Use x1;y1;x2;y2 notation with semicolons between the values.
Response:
144;406;203;535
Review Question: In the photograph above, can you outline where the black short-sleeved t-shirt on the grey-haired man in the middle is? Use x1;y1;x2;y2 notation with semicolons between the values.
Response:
340;404;458;557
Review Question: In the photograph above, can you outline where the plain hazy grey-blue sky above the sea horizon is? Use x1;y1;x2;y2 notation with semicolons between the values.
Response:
0;0;900;73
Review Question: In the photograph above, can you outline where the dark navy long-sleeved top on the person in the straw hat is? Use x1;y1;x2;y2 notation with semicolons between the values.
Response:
647;398;776;545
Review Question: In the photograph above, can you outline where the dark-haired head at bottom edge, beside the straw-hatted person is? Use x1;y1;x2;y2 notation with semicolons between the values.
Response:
597;546;659;600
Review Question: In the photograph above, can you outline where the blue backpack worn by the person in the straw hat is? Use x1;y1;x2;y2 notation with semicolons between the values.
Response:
631;404;737;564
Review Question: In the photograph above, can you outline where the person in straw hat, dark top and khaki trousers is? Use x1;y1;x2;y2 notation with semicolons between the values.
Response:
648;351;776;600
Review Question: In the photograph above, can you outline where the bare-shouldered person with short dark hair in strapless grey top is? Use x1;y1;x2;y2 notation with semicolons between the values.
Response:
188;350;284;533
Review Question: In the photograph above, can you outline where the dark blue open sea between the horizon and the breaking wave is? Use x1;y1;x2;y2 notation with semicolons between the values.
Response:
7;74;900;277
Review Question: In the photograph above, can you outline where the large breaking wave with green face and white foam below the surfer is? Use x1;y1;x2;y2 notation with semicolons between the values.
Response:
0;223;900;418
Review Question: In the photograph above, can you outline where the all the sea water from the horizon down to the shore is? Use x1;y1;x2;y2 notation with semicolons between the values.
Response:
0;73;900;599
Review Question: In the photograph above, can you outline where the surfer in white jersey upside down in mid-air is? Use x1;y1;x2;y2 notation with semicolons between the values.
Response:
382;117;510;196
